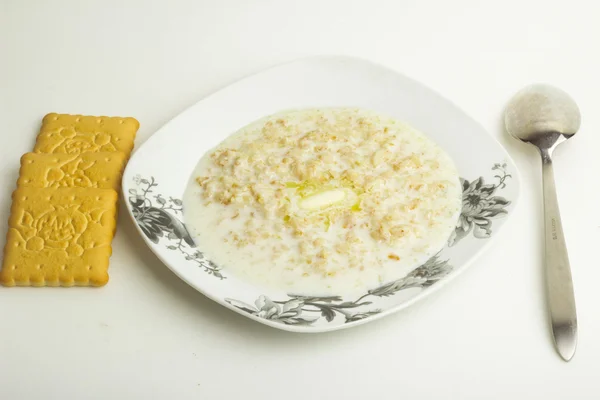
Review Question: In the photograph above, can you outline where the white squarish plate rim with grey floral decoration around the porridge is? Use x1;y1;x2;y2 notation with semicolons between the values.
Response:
123;56;519;332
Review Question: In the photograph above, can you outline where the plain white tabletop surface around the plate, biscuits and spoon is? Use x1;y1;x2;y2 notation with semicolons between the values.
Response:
0;0;600;400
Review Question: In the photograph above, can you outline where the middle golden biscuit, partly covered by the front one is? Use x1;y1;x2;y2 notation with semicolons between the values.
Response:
17;152;127;190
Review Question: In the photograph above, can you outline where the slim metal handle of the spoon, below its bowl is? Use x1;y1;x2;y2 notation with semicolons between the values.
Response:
542;150;577;361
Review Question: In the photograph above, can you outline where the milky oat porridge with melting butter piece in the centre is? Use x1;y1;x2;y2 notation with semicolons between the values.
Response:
183;108;461;295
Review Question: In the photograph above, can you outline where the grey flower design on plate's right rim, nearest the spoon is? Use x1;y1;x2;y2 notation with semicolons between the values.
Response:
448;164;511;246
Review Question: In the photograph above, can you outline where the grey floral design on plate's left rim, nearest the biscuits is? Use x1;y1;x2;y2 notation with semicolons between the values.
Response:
129;176;225;279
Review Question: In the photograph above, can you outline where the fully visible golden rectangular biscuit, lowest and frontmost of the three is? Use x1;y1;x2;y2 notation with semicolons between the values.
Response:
0;187;118;286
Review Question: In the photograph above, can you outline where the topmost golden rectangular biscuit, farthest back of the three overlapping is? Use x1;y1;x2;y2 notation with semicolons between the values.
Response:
33;113;140;157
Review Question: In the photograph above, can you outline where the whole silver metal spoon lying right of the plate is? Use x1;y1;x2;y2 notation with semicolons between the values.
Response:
504;85;581;361
